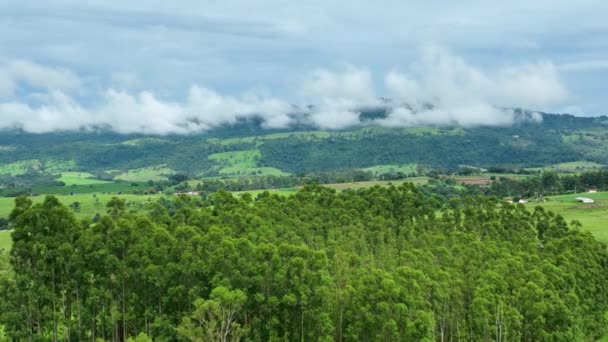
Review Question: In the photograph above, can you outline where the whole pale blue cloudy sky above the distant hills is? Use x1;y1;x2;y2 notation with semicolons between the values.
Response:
0;0;608;134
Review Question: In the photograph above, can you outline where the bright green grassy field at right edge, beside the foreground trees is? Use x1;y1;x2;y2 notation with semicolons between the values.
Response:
527;192;608;242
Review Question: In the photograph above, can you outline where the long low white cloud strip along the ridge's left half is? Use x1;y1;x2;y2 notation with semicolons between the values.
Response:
0;86;292;134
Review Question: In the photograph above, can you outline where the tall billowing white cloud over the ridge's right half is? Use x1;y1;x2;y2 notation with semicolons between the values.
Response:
379;47;569;126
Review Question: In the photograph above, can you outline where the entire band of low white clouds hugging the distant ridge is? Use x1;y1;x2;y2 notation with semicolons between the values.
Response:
0;47;570;134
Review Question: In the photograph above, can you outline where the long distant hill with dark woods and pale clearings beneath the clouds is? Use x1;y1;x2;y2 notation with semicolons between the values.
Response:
0;110;608;179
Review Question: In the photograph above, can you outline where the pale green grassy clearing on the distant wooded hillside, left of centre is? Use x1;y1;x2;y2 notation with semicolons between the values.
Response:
208;150;289;176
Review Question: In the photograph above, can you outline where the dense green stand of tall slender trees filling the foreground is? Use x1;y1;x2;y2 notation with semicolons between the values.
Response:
0;184;608;341
